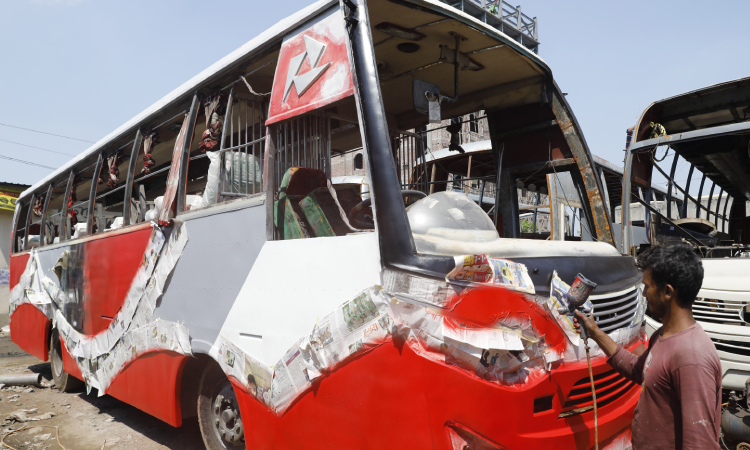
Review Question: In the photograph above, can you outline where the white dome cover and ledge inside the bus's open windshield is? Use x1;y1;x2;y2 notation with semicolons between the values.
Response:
407;191;620;258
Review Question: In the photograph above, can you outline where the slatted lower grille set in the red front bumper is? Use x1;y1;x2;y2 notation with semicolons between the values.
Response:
559;370;636;418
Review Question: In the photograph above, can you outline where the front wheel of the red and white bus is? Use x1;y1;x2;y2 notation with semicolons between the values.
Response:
198;365;245;450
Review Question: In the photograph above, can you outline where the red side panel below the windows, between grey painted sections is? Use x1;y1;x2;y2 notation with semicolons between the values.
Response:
79;226;151;335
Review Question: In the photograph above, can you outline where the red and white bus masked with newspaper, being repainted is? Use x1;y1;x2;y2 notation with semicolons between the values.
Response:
10;0;646;450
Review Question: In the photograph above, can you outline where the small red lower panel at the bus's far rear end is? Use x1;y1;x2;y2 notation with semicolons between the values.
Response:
10;302;52;361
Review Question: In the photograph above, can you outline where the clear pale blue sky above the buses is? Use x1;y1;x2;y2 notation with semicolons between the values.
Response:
0;0;750;195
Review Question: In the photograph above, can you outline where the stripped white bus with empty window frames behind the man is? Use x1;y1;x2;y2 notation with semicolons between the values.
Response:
623;78;750;391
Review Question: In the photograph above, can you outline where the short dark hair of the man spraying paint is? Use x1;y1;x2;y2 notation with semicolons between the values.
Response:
636;244;703;308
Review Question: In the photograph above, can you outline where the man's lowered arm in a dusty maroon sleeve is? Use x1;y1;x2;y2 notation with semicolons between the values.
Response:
672;364;720;449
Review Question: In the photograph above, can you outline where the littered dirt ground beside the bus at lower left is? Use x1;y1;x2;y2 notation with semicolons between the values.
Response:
0;332;205;450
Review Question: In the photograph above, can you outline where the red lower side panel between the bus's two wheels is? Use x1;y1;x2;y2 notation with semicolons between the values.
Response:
106;352;188;427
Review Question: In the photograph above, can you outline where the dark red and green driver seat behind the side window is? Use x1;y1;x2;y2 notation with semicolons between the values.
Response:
274;167;360;240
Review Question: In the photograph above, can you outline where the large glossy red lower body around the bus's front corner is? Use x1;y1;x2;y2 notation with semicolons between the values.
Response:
233;343;640;450
